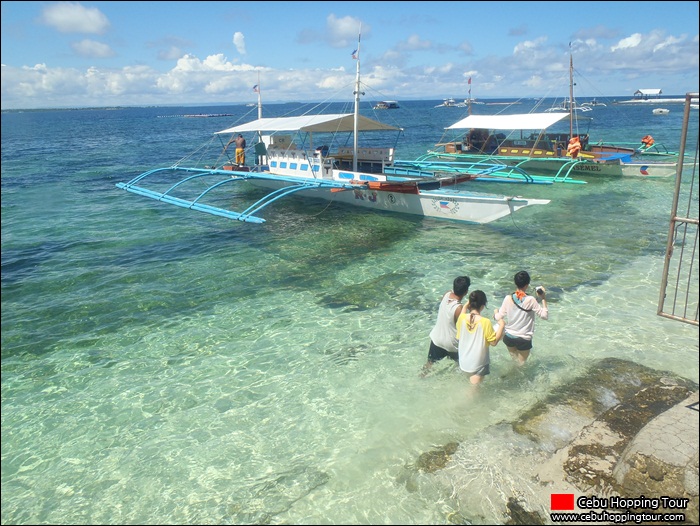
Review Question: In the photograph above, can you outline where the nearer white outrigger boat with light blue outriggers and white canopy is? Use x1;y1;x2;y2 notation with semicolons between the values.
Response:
117;36;549;223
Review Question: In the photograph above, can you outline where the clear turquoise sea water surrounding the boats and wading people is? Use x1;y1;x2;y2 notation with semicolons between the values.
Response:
1;97;699;524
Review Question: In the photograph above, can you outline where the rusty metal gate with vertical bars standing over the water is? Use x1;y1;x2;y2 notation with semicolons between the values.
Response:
657;93;700;326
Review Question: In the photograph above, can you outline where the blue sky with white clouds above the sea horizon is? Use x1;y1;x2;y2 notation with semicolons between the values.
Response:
0;0;699;109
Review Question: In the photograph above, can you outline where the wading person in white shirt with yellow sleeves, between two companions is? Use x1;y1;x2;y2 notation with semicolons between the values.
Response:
457;290;506;385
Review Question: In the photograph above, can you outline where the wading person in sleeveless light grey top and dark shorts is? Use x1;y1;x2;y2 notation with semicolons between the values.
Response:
422;276;471;375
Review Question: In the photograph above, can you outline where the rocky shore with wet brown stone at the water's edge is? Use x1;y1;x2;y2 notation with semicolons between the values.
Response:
401;358;699;524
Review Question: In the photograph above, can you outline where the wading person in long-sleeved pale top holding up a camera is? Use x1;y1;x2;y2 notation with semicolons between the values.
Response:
494;270;549;365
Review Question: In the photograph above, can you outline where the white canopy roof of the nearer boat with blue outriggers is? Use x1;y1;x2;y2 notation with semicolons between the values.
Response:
216;113;401;135
